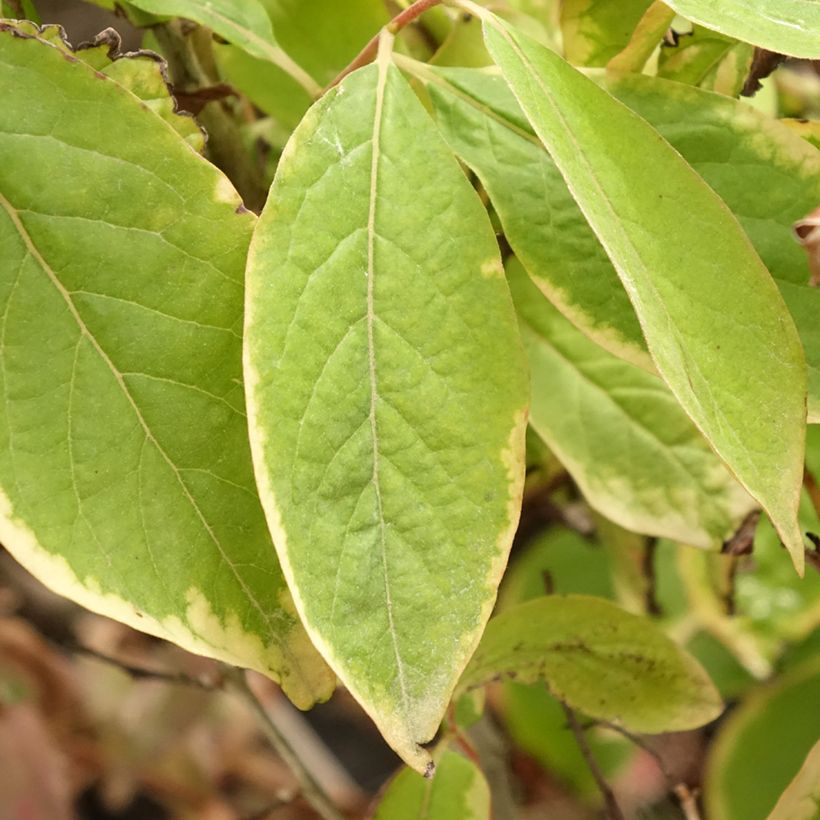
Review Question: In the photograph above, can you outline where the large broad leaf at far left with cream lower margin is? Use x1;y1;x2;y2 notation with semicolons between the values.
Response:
0;25;333;706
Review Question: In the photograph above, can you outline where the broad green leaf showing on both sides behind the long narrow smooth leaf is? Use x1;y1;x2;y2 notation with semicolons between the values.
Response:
420;61;820;421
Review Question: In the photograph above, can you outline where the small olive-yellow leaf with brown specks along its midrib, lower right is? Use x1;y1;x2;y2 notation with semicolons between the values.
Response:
459;595;723;734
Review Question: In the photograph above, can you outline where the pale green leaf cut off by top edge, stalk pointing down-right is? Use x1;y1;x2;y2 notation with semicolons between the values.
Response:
129;0;322;97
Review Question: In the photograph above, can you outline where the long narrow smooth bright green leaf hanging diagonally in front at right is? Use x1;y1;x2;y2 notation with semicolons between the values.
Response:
485;15;806;572
